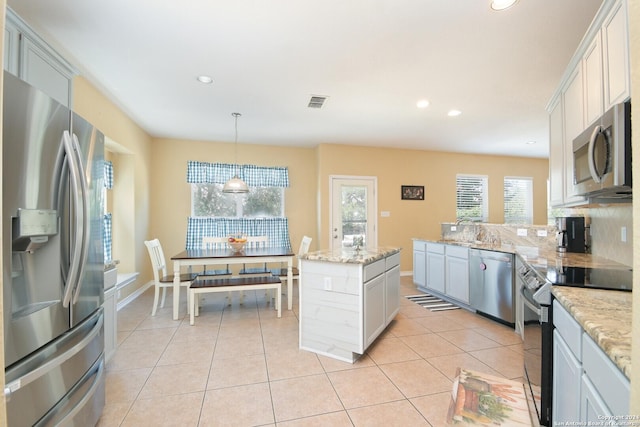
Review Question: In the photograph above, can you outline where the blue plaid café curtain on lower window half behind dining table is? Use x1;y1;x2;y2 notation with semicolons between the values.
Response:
186;217;291;249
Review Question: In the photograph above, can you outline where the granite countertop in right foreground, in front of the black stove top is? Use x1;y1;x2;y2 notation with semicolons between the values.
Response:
551;286;632;378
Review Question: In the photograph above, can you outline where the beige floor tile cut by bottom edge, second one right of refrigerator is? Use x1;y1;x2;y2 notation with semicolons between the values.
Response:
122;392;204;427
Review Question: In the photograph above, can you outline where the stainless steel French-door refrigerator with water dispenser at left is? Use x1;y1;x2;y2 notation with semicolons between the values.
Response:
2;72;105;427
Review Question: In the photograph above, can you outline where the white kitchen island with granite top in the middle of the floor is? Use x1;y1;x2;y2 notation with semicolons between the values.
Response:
299;248;400;363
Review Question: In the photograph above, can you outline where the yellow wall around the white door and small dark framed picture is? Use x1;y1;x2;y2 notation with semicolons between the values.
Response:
318;144;549;272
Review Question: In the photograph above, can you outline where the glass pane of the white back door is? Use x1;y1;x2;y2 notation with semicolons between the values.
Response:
342;185;367;247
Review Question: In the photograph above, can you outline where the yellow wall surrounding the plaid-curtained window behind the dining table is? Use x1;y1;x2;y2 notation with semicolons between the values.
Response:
150;139;317;258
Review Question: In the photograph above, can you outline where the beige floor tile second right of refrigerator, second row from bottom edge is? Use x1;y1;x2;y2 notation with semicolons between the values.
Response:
139;363;209;399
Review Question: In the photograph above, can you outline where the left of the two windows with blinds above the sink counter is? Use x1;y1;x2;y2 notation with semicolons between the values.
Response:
456;174;489;222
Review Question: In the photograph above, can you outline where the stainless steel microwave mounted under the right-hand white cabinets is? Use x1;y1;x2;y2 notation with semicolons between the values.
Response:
573;100;631;201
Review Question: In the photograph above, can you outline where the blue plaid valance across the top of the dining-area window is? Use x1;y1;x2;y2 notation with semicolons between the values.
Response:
182;161;289;187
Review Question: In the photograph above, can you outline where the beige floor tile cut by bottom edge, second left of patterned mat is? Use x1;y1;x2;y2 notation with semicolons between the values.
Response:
347;400;429;427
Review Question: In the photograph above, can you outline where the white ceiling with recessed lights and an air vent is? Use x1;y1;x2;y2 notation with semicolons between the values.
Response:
8;0;602;157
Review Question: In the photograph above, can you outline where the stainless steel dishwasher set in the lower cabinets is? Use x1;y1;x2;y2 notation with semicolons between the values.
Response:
469;249;515;326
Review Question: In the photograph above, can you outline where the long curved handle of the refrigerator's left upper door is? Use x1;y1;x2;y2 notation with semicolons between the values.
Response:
62;130;84;307
